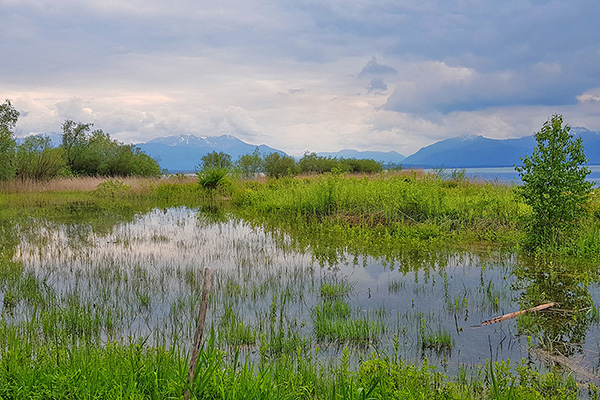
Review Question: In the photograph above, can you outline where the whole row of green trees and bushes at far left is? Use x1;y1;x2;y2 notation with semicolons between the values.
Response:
0;99;161;180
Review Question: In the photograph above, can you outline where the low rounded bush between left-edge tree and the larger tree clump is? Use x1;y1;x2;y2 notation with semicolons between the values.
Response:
16;135;66;180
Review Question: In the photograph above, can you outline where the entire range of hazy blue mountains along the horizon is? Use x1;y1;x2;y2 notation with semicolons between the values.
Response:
17;127;600;172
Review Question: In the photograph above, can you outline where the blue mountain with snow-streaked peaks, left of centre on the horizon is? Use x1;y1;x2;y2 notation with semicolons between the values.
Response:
136;134;285;172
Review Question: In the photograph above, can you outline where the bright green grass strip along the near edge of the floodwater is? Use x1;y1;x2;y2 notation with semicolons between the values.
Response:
0;326;578;399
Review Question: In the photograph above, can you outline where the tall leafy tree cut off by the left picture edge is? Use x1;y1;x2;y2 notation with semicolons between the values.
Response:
0;99;19;180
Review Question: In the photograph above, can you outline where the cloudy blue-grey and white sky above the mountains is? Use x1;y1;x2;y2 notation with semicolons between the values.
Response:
0;0;600;155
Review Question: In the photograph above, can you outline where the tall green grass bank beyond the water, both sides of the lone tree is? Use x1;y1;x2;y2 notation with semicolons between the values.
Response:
231;173;600;260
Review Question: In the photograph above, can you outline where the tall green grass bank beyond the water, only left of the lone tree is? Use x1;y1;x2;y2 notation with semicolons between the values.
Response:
233;174;526;245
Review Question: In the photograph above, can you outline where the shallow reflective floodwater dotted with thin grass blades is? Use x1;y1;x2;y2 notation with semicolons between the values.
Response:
9;208;600;381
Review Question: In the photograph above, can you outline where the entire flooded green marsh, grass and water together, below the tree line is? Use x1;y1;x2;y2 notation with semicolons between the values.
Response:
0;171;600;399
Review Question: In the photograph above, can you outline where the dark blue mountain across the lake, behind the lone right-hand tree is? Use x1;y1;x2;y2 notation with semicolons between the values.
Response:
402;128;600;168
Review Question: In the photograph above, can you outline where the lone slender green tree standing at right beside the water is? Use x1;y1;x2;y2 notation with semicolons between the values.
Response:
515;115;592;249
